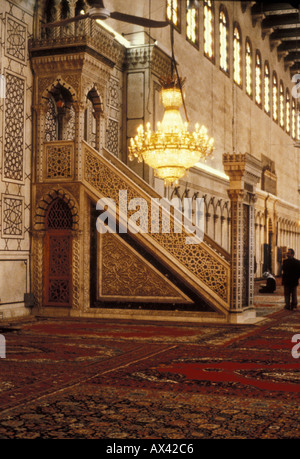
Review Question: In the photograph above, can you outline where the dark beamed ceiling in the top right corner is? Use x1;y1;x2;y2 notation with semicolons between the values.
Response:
242;0;300;75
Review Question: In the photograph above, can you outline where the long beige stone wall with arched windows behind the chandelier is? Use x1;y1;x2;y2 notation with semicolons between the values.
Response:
118;0;300;277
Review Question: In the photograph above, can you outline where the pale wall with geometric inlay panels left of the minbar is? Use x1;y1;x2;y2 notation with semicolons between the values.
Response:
0;0;34;319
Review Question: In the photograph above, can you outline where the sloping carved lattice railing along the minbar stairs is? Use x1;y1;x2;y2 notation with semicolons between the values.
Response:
82;141;230;313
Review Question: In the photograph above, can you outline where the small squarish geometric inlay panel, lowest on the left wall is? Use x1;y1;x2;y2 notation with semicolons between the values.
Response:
2;195;24;238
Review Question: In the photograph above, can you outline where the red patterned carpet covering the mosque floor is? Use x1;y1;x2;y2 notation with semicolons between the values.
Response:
0;291;300;439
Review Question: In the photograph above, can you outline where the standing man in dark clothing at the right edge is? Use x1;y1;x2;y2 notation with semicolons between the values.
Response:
282;249;300;310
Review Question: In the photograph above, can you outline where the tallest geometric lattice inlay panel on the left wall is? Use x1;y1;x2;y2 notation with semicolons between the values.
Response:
3;72;25;181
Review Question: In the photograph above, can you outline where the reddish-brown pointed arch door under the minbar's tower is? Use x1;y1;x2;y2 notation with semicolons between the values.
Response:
44;198;73;307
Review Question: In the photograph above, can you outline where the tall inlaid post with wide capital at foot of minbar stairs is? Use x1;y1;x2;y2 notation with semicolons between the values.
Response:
223;153;262;322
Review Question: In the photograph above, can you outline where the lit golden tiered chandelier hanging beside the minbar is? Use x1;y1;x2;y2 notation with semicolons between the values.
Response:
129;13;214;185
